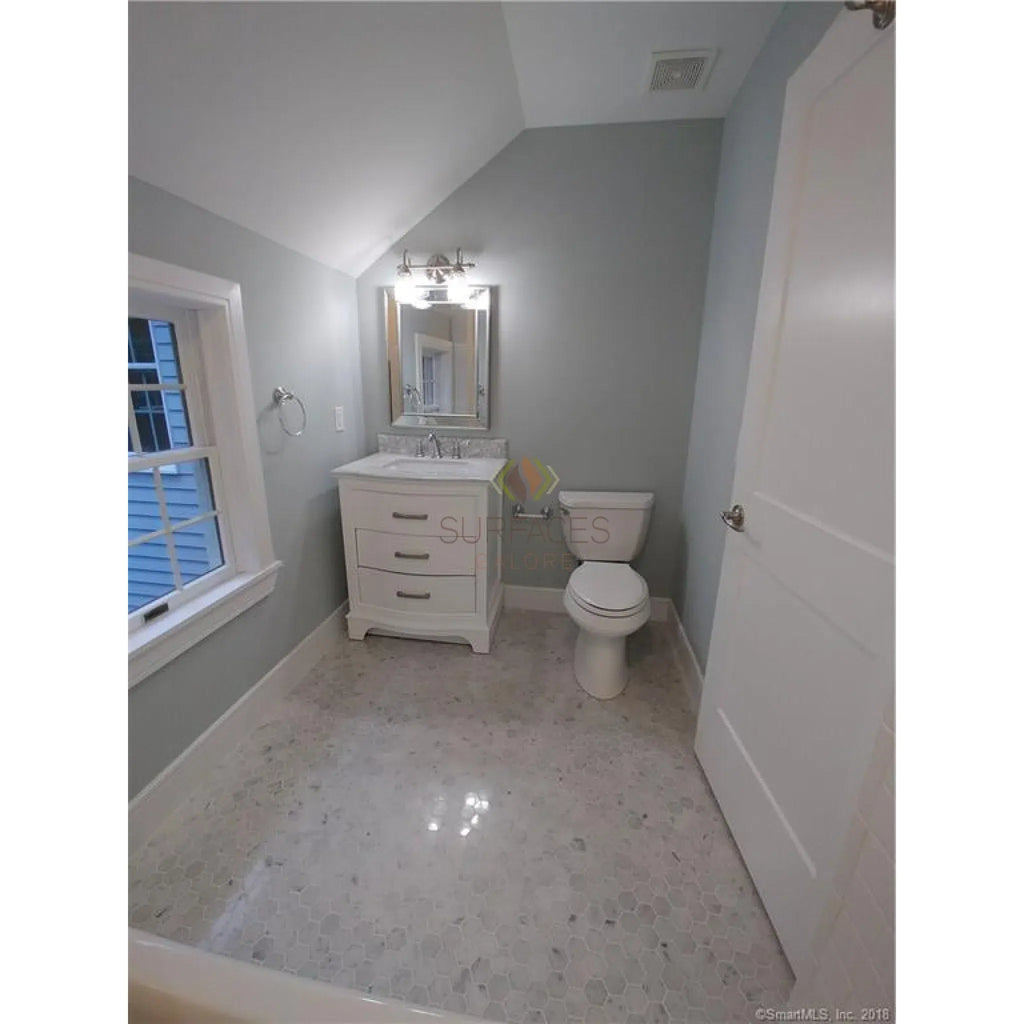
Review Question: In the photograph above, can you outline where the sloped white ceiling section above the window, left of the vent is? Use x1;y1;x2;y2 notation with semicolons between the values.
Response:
128;3;523;275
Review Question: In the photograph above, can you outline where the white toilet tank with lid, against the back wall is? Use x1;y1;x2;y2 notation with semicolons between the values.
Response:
558;490;654;562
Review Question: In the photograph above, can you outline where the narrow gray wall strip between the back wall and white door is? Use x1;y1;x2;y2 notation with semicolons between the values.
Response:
673;3;839;669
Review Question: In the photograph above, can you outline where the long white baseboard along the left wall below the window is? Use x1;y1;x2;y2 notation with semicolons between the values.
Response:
128;600;348;852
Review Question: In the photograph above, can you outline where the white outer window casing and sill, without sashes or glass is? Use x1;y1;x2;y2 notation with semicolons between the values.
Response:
128;253;282;689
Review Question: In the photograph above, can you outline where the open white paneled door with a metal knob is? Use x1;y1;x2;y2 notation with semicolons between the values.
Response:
696;12;894;974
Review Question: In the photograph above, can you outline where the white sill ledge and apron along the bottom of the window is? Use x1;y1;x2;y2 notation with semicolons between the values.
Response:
128;561;282;689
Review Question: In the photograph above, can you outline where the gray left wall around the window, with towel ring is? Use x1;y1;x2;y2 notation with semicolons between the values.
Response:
128;178;364;794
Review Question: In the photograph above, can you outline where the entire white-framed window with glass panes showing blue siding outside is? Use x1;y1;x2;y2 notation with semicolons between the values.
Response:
128;255;281;685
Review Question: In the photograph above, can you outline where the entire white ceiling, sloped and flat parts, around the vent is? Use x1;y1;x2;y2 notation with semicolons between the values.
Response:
128;2;781;276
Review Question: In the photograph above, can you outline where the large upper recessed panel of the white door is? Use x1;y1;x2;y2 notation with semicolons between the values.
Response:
757;36;894;552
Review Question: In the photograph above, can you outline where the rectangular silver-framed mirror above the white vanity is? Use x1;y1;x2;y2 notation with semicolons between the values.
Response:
383;285;494;430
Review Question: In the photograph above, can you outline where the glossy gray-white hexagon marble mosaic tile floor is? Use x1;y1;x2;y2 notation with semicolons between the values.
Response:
129;610;793;1024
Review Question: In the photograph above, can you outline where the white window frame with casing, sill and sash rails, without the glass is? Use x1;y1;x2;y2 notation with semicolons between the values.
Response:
128;253;282;688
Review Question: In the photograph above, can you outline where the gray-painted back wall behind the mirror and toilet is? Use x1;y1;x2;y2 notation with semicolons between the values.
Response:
358;120;721;596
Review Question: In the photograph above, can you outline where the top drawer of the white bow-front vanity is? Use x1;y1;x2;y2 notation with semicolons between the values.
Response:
341;490;475;536
